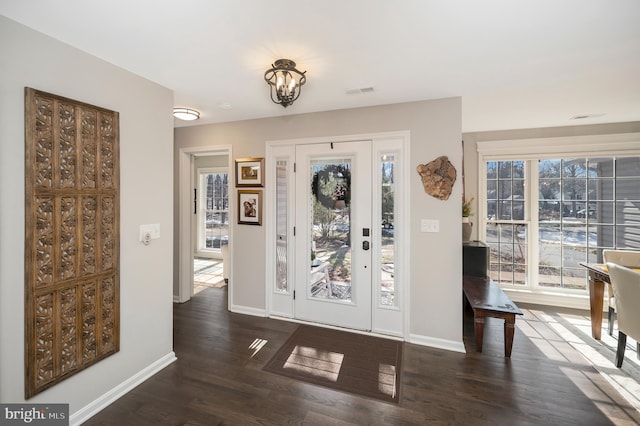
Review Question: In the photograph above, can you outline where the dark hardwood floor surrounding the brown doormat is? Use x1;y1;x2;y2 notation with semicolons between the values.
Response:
85;288;640;426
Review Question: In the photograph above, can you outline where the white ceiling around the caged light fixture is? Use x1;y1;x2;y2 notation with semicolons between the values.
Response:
0;0;640;132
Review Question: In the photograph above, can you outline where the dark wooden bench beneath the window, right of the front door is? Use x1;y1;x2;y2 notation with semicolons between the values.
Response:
462;275;522;357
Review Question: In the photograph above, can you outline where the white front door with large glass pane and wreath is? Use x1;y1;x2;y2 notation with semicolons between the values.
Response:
294;141;377;330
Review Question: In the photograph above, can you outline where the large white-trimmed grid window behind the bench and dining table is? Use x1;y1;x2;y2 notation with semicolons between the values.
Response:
478;134;640;294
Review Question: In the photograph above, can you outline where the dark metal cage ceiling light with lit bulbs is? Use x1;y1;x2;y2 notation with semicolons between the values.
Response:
264;59;307;108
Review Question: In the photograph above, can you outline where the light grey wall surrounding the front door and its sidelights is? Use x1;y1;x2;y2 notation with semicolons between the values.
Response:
174;98;462;349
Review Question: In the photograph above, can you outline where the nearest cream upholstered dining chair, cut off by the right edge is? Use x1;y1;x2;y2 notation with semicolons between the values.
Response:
607;262;640;368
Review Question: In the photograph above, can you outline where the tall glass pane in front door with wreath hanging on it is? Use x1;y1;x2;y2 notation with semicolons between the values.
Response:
308;159;352;302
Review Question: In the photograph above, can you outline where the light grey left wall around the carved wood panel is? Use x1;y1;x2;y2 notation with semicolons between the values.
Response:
0;16;173;414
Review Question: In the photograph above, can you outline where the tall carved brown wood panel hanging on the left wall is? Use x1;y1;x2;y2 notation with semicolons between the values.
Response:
25;88;120;398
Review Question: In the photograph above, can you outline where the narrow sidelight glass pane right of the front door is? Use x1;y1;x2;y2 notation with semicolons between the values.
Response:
380;155;397;306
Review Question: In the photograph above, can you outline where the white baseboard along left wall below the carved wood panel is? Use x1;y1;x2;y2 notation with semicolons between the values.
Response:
69;351;177;426
